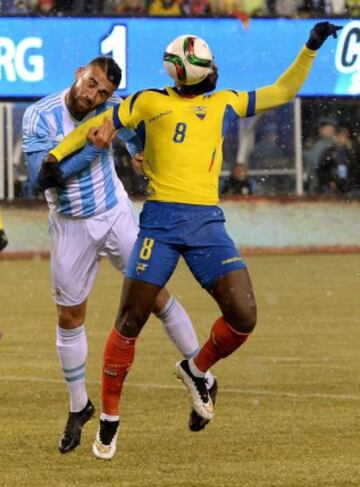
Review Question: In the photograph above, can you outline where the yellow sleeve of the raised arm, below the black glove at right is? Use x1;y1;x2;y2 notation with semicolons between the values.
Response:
255;46;316;113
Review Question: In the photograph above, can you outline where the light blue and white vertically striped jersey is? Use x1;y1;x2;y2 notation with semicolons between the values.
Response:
23;90;134;217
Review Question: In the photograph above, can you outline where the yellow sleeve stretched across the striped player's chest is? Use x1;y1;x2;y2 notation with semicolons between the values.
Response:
50;105;114;162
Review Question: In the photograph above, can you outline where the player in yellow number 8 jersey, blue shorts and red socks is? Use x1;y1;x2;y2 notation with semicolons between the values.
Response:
44;22;340;459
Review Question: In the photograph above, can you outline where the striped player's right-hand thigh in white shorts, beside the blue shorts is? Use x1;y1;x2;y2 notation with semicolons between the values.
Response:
102;200;139;272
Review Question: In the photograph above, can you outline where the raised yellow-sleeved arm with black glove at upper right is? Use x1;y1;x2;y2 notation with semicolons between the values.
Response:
253;22;342;113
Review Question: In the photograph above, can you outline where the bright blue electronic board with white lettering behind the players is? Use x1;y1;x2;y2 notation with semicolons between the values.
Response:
0;17;360;100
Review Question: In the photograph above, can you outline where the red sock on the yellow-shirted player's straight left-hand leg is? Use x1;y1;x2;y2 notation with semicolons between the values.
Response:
101;328;136;416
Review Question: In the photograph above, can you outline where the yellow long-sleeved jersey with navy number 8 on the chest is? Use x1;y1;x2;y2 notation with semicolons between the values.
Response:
51;47;316;205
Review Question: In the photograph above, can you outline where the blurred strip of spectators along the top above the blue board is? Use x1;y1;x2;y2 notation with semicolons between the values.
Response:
0;0;360;19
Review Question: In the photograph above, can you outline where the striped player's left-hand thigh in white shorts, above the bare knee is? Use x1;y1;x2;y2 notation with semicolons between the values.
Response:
49;215;100;306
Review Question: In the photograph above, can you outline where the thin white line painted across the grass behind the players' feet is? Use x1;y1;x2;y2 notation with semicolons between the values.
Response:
0;375;360;401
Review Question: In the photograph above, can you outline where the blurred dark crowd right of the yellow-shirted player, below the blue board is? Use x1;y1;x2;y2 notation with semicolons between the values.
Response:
220;101;360;198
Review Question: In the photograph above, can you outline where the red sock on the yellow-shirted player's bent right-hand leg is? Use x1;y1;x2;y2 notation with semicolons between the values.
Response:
194;316;250;372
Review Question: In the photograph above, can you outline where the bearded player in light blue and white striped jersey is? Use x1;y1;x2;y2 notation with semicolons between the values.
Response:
23;57;217;453
